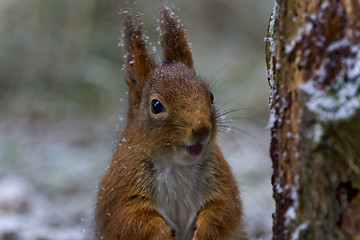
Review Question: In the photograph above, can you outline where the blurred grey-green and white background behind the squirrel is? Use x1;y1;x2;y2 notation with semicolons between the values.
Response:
0;0;274;240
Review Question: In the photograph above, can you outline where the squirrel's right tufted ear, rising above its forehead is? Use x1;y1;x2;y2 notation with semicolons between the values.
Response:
159;3;194;68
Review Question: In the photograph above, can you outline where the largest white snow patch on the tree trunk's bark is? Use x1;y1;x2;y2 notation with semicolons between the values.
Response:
300;42;360;121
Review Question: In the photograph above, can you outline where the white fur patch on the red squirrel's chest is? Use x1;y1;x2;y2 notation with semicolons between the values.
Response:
155;158;207;240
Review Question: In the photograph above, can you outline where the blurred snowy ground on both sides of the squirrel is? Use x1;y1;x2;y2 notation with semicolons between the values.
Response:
0;117;273;240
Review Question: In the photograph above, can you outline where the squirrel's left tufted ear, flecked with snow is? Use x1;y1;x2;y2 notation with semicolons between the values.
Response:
123;10;153;105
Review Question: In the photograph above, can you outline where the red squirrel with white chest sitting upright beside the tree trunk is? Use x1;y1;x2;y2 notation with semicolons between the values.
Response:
95;5;247;240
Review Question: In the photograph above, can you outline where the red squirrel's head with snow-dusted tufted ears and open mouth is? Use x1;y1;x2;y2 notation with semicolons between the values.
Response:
123;5;217;164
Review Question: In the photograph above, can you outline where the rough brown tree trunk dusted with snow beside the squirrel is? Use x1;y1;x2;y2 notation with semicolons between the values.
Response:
266;0;360;240
